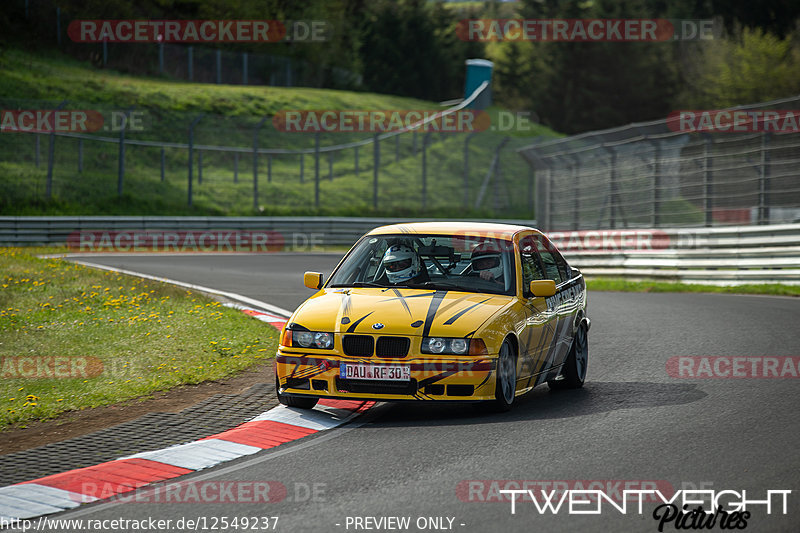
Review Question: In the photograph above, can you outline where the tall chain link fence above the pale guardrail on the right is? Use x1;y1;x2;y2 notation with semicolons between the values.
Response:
519;97;800;231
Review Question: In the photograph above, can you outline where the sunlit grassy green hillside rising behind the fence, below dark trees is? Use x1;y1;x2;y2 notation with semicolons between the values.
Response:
0;50;554;217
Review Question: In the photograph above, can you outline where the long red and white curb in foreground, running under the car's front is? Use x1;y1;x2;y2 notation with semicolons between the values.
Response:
0;399;375;523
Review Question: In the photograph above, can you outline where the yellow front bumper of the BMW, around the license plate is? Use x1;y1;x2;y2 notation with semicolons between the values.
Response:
275;351;497;402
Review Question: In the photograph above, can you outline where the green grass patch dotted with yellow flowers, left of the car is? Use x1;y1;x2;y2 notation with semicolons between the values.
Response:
0;248;278;430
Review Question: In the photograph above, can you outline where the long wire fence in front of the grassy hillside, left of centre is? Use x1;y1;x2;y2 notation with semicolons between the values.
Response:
0;83;534;219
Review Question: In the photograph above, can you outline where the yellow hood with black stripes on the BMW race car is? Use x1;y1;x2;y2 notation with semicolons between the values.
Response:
291;288;513;337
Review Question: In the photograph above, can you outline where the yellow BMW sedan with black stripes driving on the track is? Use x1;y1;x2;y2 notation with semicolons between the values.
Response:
275;222;591;411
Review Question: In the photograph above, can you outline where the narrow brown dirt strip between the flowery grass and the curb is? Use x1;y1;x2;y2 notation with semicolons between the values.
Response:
0;361;275;455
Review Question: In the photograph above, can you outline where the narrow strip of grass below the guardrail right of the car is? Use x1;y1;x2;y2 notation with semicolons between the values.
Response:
586;278;800;296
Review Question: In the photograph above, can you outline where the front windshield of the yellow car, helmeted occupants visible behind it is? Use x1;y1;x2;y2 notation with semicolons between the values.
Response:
327;234;516;295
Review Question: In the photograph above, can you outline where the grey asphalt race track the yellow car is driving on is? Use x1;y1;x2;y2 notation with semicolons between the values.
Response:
57;253;800;532
